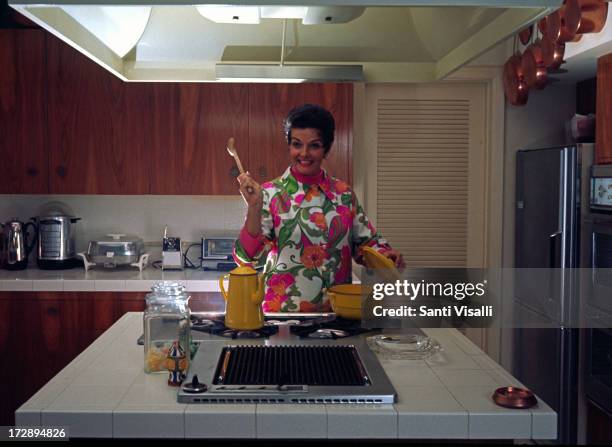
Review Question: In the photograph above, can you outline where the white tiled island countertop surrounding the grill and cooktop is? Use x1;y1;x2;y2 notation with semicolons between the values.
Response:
15;313;557;439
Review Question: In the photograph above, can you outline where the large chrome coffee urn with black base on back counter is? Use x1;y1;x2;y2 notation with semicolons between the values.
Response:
36;202;81;270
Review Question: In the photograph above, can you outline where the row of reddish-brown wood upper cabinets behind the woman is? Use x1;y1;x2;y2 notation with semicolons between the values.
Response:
0;29;353;195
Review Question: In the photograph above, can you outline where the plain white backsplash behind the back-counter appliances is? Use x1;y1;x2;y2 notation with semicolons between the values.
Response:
0;194;246;257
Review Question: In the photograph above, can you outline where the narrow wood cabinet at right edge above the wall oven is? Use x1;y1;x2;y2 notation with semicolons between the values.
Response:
595;53;612;164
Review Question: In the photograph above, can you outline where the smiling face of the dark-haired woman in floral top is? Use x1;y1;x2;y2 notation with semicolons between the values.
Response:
289;128;325;175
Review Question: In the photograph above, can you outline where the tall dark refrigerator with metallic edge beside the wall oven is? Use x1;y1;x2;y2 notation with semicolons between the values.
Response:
512;144;593;444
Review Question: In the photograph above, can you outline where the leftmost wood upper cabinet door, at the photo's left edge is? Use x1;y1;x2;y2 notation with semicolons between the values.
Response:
0;29;49;194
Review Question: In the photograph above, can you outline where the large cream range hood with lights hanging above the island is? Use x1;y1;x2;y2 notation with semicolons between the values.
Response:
9;0;562;82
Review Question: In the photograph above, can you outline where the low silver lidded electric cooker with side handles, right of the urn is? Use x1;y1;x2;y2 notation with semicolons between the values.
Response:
78;233;149;271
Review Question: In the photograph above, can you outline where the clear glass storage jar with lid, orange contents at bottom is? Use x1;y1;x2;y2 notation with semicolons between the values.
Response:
143;282;191;373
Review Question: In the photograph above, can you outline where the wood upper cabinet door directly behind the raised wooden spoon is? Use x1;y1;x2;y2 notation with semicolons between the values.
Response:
151;83;249;195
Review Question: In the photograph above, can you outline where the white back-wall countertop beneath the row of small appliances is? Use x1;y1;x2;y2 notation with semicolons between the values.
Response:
0;267;227;292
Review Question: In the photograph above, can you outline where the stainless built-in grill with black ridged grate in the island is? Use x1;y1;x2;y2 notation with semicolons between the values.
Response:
178;315;396;404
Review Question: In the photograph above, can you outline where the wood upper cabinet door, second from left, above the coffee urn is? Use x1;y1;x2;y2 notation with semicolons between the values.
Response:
47;35;151;194
